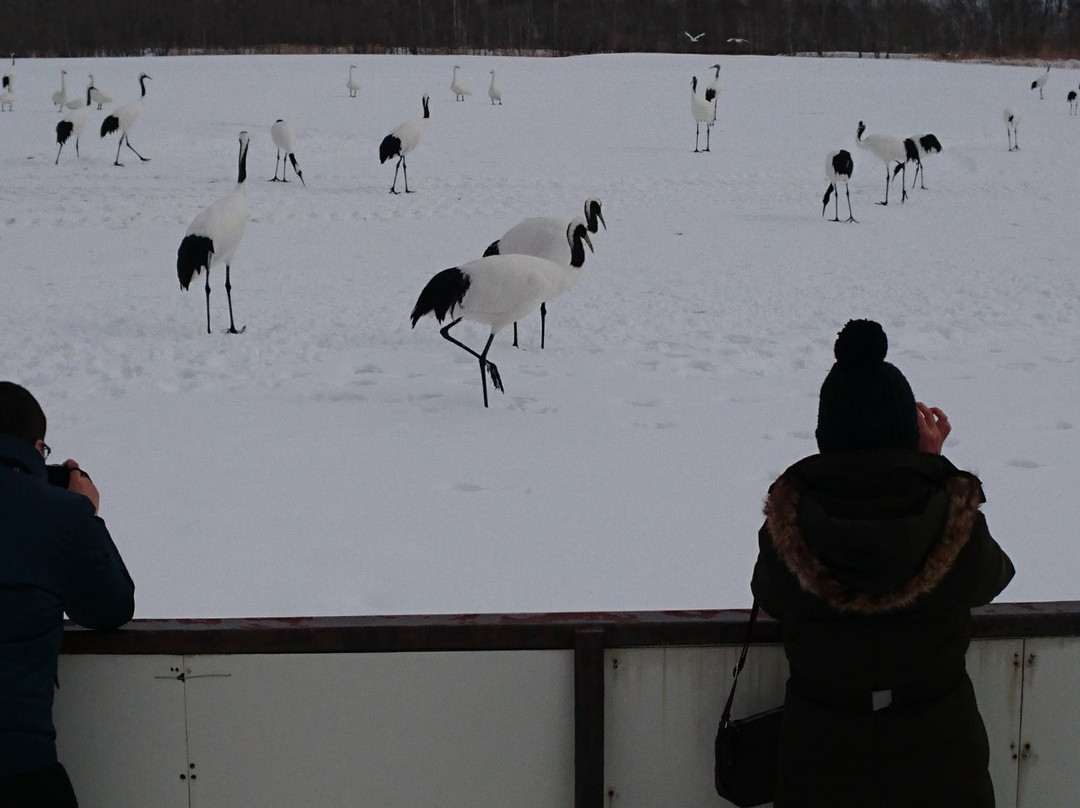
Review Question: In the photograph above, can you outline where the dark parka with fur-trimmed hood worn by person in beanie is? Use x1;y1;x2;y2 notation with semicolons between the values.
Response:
753;449;1013;808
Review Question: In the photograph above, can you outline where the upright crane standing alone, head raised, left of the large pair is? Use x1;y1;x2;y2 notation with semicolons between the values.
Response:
176;132;248;334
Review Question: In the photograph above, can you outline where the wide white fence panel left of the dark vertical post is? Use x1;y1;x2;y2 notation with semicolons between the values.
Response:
187;651;573;808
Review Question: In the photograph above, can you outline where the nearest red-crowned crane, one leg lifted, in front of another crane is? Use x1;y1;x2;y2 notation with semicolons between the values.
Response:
409;219;592;407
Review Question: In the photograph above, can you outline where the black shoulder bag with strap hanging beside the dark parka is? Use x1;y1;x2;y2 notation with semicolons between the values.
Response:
715;600;784;808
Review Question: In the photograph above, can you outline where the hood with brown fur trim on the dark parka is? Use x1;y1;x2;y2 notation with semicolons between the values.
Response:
765;450;985;614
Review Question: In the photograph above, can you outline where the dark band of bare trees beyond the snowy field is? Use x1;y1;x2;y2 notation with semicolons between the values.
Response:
0;0;1080;58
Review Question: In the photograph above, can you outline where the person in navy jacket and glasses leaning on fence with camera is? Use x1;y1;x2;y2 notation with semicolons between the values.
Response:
0;381;135;808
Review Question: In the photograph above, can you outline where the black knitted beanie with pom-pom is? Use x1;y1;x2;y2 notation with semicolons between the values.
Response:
816;320;919;452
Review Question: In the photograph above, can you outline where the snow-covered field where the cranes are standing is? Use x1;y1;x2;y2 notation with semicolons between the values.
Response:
0;55;1080;617
